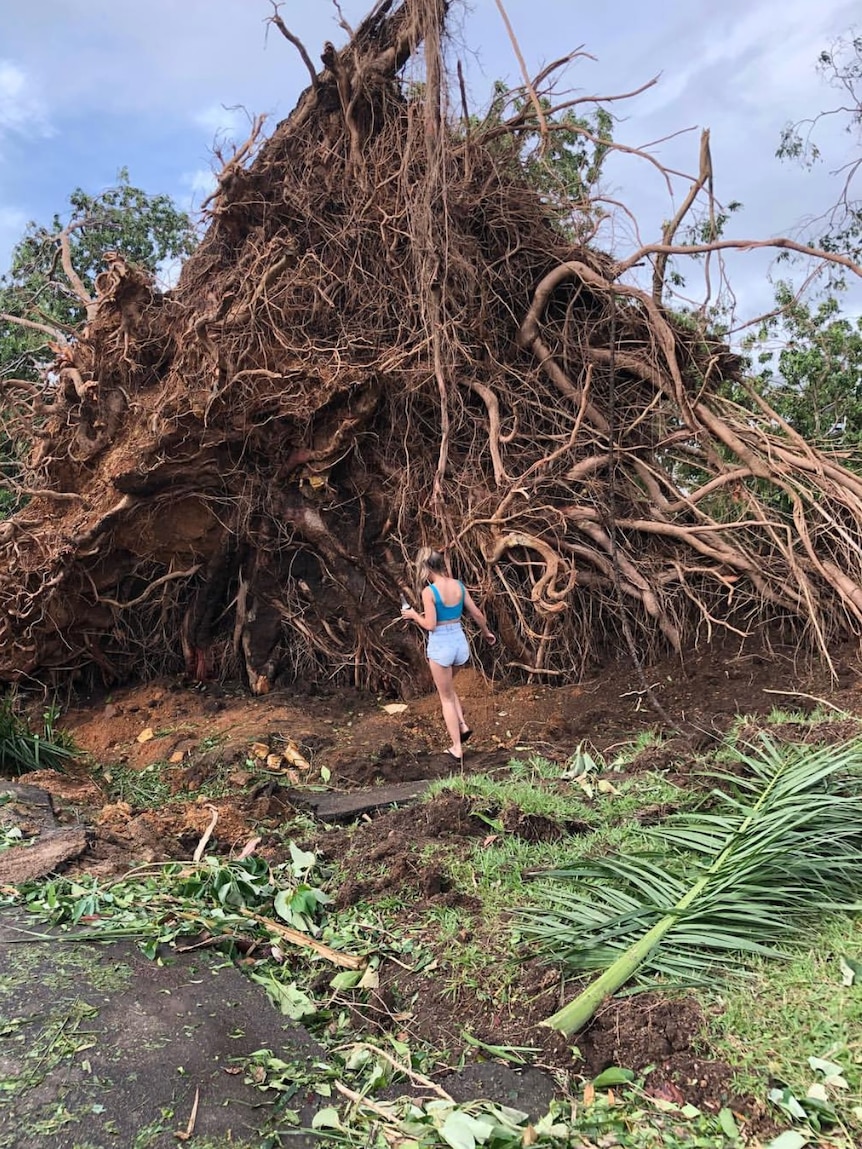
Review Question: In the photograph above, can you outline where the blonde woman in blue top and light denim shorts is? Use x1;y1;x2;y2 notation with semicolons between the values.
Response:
401;547;497;763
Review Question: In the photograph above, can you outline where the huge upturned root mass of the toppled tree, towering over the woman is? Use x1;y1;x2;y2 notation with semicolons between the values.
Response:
0;0;862;692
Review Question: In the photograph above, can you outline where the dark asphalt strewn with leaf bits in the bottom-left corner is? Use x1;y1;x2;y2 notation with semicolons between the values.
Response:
0;913;324;1149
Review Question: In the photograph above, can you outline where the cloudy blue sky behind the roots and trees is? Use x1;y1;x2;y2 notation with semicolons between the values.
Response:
0;0;859;314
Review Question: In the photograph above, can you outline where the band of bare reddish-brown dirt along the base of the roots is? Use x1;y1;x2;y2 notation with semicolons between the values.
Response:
50;649;860;804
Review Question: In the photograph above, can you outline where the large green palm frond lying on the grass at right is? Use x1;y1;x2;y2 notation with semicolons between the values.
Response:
521;735;862;1034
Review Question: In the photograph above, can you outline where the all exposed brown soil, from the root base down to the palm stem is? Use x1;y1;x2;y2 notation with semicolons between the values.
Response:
8;654;862;1117
